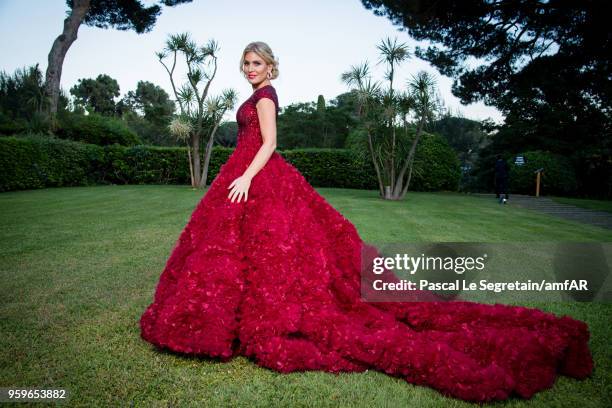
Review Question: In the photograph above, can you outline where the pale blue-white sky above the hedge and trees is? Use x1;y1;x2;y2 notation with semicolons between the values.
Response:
0;0;503;122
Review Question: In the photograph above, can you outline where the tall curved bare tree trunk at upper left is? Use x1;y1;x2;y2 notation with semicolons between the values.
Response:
45;0;90;118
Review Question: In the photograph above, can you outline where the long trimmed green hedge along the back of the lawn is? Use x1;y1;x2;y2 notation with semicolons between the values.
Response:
0;135;460;191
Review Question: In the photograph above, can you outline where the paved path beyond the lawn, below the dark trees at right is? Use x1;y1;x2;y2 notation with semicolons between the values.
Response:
470;193;612;229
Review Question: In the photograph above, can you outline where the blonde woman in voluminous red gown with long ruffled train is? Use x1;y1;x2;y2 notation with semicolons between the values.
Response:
140;42;593;401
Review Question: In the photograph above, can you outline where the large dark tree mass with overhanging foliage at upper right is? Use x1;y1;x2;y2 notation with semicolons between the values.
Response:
362;0;612;196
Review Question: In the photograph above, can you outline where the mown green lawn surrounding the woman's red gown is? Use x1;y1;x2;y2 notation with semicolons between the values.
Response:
0;186;612;408
